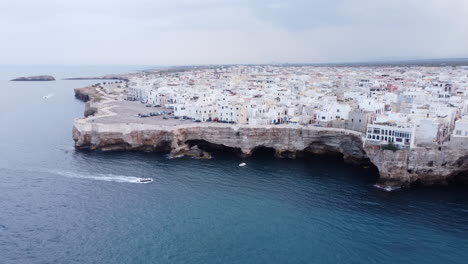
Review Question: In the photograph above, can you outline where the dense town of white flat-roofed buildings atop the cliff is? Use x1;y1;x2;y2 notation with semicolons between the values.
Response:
122;66;468;149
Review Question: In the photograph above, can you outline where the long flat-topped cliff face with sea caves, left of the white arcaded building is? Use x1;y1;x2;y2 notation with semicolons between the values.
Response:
73;123;368;162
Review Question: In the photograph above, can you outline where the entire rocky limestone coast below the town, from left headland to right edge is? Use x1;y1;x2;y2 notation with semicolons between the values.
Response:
73;87;468;187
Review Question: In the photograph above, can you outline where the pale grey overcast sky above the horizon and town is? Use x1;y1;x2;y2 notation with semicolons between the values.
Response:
0;0;468;65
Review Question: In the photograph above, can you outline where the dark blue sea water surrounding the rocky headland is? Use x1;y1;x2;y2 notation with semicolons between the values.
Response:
0;66;468;264
